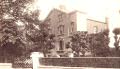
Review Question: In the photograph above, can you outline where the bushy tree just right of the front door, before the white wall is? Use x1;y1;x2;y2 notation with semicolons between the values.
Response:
71;32;88;57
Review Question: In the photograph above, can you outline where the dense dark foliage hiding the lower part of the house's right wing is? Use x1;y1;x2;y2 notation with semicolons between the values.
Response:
71;30;110;57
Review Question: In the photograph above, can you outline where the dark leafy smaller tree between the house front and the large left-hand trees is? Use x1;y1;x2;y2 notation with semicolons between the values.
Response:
26;23;55;56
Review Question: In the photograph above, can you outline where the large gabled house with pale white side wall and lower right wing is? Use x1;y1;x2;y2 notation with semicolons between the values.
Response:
44;9;108;51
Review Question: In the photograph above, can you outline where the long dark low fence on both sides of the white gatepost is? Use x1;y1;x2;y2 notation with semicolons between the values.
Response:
13;57;120;68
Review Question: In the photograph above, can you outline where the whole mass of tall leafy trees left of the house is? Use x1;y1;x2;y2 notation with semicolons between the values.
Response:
0;0;54;57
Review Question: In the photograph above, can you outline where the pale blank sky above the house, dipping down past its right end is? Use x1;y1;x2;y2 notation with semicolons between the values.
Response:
34;0;120;46
